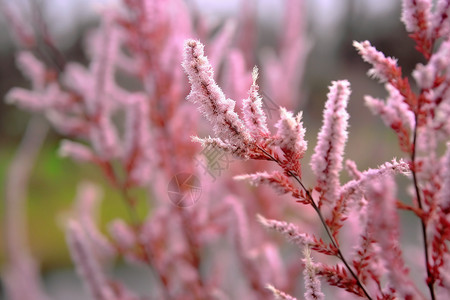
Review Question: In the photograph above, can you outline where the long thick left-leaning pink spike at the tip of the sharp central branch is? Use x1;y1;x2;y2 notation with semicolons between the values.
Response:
183;40;253;149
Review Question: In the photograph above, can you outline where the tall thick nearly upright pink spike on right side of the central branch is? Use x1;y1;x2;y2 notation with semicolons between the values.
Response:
310;80;351;206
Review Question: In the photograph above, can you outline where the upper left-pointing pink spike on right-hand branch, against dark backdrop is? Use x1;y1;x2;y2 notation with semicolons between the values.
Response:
353;41;401;82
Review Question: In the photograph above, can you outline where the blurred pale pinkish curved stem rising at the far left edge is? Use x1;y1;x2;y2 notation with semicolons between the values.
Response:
2;116;49;300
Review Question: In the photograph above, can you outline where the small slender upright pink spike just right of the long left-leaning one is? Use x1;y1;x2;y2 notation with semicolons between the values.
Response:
242;66;269;139
